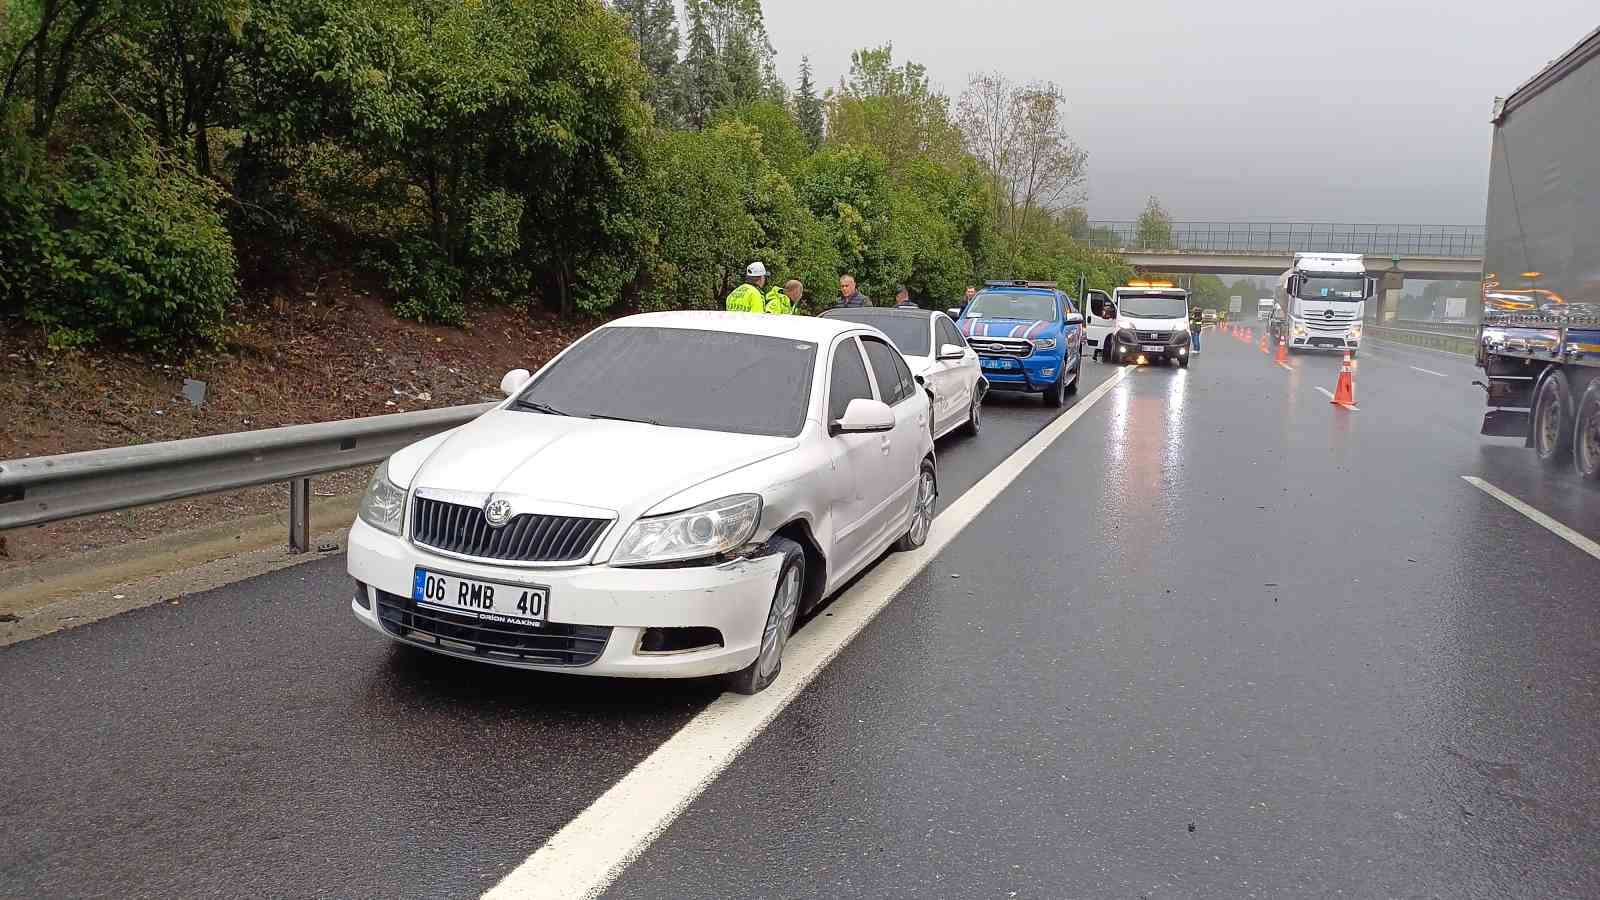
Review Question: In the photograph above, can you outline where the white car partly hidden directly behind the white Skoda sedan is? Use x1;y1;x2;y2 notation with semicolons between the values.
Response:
822;306;989;439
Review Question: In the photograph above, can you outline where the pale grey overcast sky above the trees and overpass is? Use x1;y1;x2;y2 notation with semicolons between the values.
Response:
763;0;1600;226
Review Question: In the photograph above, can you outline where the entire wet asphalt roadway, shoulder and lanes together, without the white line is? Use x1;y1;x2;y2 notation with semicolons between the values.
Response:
0;333;1600;898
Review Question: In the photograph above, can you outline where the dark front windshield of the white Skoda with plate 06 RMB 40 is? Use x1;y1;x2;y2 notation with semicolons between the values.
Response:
514;327;816;437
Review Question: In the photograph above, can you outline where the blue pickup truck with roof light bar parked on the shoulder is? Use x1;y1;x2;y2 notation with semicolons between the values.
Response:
950;282;1083;407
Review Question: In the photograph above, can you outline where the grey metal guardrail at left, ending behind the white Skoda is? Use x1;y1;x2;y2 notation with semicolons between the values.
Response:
0;404;494;552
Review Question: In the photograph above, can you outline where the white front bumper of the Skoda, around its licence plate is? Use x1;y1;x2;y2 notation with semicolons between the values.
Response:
349;520;782;677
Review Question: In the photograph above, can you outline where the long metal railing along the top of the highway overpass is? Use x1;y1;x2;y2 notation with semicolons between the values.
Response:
1080;221;1483;258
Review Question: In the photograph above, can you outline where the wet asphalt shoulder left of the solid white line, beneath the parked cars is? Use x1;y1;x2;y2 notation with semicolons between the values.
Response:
0;364;1109;897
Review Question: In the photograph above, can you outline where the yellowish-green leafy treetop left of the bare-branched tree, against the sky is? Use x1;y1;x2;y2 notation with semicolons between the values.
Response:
827;45;962;175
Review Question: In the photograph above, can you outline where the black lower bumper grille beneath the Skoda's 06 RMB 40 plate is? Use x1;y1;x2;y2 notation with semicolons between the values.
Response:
376;591;611;666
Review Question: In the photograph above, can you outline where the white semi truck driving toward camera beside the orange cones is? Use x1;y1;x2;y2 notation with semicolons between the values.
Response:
1272;253;1376;356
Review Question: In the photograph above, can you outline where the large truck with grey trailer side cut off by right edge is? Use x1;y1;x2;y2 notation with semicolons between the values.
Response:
1477;29;1600;482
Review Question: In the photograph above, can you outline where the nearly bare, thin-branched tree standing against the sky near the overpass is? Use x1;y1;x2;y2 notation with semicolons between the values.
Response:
957;72;1088;242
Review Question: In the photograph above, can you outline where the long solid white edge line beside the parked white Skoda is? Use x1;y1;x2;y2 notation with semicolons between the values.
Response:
485;368;1128;900
